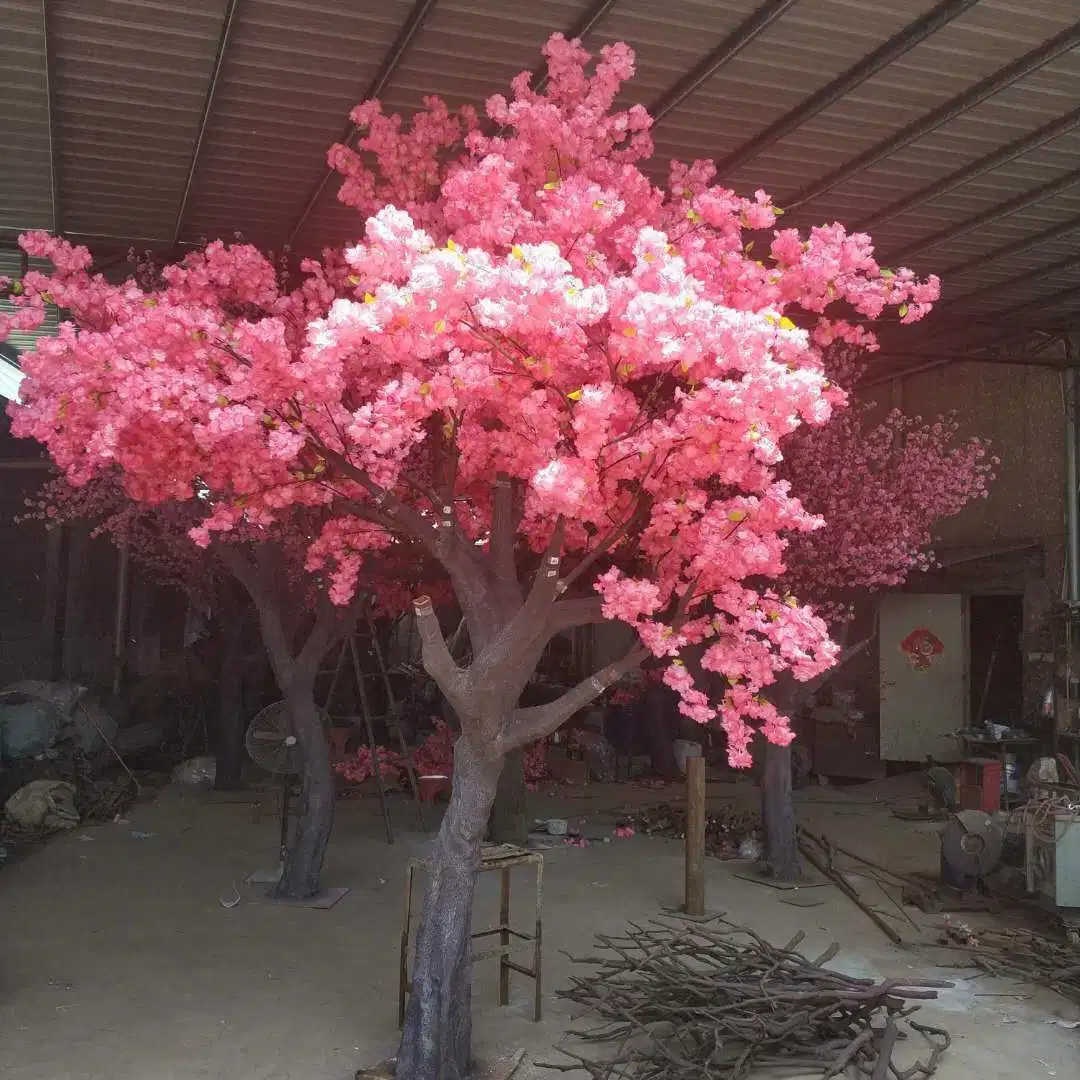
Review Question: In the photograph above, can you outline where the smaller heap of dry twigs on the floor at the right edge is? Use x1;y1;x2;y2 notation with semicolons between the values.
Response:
945;923;1080;1004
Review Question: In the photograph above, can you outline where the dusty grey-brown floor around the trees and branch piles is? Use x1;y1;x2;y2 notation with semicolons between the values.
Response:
0;785;1080;1080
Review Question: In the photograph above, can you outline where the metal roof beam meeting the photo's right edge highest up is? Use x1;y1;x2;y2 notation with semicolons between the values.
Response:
779;23;1080;211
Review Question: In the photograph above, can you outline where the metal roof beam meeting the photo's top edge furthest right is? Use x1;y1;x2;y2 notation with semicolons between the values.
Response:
716;0;978;176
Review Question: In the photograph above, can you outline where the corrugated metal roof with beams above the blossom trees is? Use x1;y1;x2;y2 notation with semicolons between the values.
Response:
0;0;1080;380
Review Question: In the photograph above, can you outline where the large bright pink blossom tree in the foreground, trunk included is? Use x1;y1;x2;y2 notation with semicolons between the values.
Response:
4;36;950;1080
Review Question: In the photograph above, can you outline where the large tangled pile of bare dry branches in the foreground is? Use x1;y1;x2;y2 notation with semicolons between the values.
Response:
546;918;949;1080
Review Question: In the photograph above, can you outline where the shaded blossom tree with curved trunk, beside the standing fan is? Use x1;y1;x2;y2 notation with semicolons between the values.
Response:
21;468;424;899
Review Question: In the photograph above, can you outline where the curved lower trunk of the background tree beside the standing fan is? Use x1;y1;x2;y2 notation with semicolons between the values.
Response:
271;672;334;900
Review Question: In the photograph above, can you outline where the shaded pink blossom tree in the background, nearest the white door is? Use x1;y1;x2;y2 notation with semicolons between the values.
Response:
761;384;995;881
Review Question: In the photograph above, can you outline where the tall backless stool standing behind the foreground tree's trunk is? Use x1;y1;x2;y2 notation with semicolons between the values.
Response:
397;843;543;1027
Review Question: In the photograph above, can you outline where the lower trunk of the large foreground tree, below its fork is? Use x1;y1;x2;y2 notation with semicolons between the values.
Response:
396;733;502;1080
